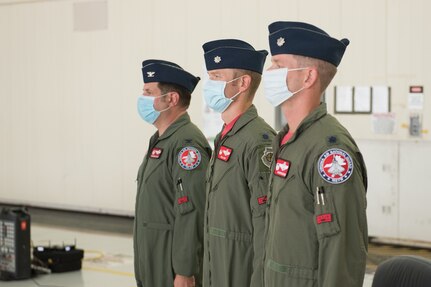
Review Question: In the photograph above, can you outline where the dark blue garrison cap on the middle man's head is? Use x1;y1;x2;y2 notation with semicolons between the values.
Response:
202;39;268;74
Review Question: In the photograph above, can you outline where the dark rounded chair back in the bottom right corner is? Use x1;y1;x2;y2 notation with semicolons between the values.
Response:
372;255;431;287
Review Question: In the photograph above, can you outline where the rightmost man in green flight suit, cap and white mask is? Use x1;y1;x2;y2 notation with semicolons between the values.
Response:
263;22;368;287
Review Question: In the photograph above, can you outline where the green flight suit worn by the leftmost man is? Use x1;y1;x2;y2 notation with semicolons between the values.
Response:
133;114;211;287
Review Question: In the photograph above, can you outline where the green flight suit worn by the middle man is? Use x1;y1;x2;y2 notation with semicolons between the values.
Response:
203;106;275;287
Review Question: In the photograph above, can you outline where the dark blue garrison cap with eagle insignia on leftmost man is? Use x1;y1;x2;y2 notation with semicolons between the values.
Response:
142;59;200;93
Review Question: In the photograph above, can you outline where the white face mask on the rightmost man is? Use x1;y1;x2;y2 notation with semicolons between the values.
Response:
263;68;308;107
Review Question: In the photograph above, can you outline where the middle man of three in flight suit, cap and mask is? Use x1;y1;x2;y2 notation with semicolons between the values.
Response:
203;39;275;287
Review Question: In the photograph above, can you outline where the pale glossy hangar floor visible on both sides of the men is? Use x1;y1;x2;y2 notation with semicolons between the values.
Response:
0;208;431;287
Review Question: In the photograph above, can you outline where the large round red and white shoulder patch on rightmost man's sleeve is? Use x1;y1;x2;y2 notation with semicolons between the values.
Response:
317;148;353;184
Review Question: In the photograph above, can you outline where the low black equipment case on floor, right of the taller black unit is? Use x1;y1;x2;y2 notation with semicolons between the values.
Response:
33;245;84;273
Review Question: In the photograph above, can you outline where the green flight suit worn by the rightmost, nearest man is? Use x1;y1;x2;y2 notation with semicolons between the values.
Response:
264;104;368;287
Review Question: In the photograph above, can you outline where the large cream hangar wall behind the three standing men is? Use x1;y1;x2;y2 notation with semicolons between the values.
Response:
0;0;431;214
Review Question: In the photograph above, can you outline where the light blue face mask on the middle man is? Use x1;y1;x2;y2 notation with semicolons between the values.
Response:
204;76;242;113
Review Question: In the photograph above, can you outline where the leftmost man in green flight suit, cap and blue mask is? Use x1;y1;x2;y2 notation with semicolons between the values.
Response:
133;60;211;287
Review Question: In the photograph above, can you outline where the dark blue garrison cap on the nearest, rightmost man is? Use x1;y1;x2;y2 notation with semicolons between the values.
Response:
268;21;350;67
